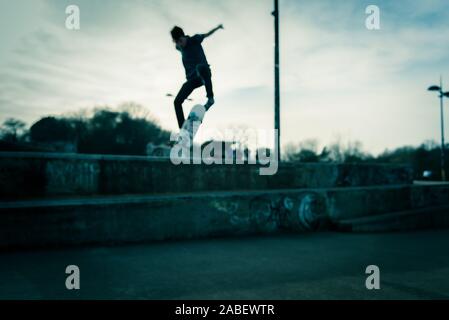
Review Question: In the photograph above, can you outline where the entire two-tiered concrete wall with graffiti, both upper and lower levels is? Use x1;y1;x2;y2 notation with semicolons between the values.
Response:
0;153;449;249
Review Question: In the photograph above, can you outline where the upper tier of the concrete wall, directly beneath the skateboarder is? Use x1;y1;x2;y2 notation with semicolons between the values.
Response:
0;152;412;199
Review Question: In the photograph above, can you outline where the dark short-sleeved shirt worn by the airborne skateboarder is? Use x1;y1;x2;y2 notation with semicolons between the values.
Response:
176;34;209;80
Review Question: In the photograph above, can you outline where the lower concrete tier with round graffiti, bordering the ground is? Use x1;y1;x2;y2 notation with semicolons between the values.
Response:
0;186;449;249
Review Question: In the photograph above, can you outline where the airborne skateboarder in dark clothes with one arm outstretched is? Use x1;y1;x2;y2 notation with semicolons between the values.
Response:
171;25;223;128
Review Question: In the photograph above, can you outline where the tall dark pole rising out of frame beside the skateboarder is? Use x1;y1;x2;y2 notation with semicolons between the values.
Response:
272;0;281;161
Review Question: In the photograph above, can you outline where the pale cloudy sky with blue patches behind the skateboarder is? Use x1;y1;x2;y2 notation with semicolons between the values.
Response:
0;0;449;154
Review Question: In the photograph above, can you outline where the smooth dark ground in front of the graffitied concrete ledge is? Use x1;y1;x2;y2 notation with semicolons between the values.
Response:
0;230;449;299
